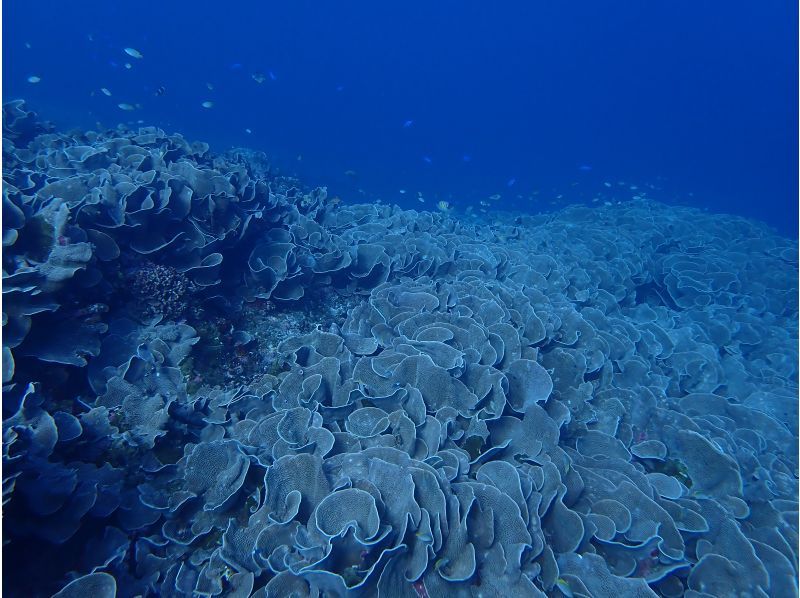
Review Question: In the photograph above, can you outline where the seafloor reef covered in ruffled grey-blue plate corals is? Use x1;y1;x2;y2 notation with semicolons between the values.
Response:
3;102;798;598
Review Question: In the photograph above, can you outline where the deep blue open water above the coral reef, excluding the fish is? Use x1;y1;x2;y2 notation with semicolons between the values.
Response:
3;0;798;236
